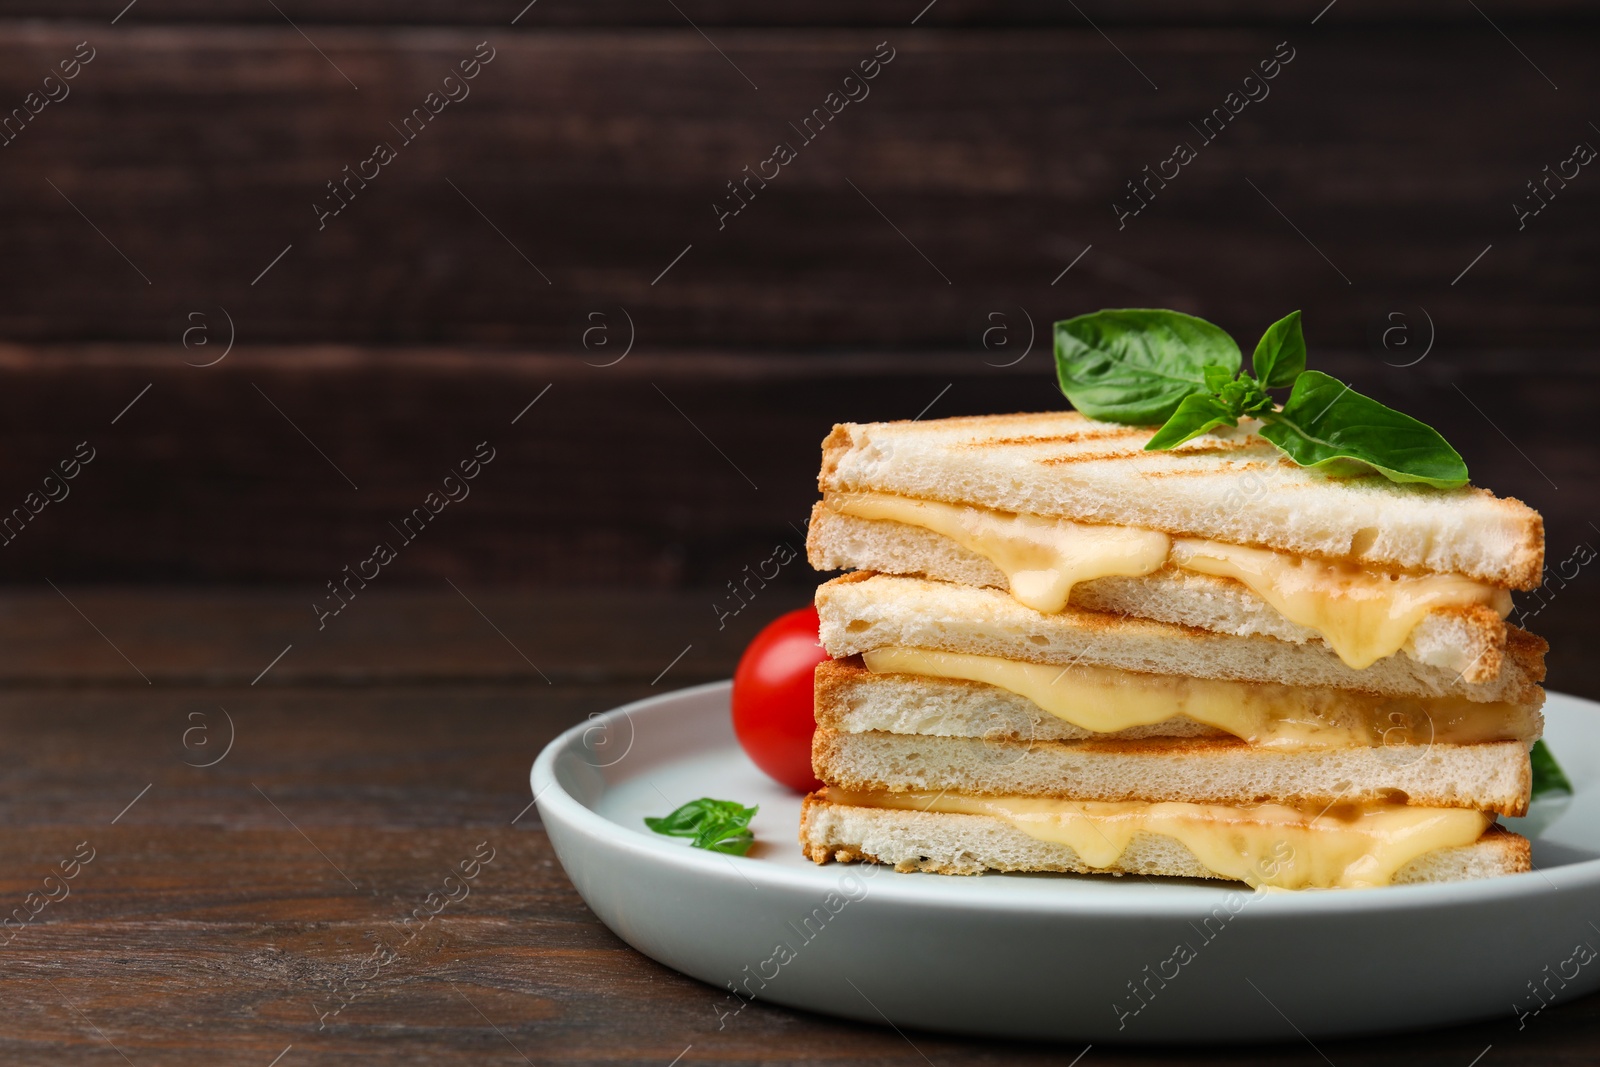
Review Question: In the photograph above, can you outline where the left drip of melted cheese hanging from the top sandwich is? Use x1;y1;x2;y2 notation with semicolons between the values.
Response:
829;493;1170;613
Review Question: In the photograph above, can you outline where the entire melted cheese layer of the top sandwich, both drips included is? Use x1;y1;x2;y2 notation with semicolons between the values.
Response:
827;493;1512;670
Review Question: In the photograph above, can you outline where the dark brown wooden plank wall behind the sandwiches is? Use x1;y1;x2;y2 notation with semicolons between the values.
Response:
0;0;1600;585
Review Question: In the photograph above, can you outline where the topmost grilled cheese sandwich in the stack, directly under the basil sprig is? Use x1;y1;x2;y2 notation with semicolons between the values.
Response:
808;413;1542;678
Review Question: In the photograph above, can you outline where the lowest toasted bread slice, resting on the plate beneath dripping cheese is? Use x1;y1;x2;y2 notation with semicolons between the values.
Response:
800;793;1531;885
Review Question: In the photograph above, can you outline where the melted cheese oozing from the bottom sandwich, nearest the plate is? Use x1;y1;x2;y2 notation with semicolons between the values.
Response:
827;787;1494;889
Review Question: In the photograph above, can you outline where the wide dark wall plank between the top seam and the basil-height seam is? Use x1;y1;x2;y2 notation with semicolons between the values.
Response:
0;22;1600;349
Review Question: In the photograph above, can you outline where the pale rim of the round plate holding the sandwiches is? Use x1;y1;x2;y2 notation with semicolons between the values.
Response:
530;678;1600;918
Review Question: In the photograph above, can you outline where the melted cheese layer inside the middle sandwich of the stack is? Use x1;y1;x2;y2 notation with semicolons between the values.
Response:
862;646;1538;749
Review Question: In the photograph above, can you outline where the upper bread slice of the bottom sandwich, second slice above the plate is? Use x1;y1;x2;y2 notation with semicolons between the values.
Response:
811;728;1533;816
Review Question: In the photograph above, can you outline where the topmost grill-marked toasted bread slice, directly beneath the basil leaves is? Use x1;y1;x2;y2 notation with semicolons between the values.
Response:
818;411;1544;589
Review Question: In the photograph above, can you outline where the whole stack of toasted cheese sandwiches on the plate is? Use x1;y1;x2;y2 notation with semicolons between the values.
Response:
800;411;1546;888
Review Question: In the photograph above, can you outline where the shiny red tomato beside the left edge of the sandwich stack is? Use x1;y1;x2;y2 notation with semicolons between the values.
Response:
733;608;829;793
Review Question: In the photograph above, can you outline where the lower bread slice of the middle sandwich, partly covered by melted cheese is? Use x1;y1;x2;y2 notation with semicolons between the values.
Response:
813;656;1544;749
